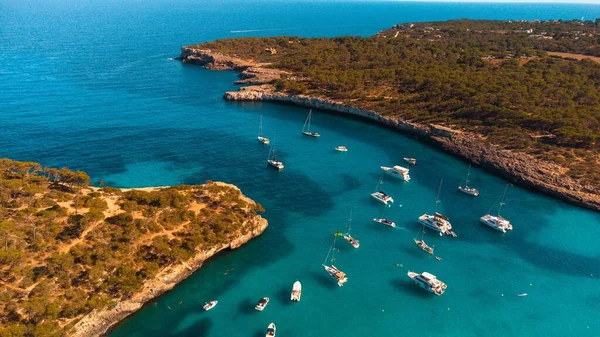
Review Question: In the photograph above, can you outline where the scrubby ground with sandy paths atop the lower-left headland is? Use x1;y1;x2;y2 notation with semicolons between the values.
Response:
0;159;264;337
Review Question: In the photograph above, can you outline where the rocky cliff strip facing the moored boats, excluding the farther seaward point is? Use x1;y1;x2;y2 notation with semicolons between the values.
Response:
224;85;600;210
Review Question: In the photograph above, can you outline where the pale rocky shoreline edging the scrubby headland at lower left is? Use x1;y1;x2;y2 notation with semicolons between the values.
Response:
69;183;268;337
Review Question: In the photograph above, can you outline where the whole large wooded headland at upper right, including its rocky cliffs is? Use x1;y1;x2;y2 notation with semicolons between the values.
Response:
180;20;600;210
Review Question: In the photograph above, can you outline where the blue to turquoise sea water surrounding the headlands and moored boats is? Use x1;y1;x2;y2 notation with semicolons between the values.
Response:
0;0;600;337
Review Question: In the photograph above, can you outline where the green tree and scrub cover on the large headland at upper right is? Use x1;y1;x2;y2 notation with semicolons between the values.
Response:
195;20;600;187
